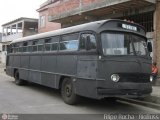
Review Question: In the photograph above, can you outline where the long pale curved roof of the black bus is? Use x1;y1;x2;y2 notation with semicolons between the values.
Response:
11;19;144;44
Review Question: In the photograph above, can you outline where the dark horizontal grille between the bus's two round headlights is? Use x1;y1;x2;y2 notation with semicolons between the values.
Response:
119;74;150;83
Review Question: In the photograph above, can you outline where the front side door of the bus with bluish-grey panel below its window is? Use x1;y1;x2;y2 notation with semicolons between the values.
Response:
76;32;97;97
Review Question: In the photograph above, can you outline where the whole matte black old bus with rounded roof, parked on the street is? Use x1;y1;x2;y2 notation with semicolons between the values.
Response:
6;19;152;104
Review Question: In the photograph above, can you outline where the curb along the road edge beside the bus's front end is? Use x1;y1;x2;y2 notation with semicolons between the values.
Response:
118;96;160;110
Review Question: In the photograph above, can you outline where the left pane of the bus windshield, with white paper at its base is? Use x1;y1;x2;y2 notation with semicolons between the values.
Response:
101;33;134;55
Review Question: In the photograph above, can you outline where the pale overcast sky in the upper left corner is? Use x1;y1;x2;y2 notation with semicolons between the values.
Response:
0;0;47;32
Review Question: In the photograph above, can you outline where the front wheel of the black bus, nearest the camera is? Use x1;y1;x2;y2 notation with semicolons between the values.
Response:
61;78;78;105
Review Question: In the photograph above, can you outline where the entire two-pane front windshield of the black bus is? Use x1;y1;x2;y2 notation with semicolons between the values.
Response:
101;32;147;56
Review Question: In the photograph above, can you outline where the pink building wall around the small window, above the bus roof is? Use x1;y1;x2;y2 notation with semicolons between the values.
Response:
38;9;61;33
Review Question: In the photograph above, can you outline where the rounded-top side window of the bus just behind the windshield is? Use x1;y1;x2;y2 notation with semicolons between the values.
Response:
79;33;96;50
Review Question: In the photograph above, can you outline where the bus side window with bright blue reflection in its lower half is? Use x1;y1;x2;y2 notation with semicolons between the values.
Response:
60;33;79;50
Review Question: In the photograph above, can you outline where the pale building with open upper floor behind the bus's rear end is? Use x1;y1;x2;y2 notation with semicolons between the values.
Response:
0;17;38;64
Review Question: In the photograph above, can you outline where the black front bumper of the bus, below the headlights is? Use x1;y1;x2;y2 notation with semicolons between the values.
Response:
97;83;152;98
